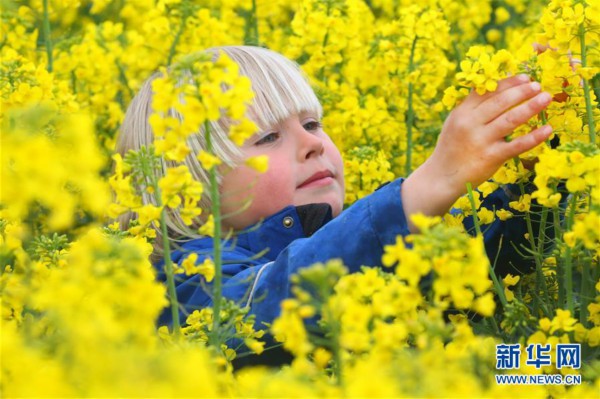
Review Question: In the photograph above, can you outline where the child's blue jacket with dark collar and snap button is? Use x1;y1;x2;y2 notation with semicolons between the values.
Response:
158;179;531;328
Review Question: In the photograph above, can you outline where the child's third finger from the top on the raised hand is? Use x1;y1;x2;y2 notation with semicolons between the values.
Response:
487;92;552;137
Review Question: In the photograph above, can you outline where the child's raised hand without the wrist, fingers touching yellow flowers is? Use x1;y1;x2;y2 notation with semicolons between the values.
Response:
431;75;552;192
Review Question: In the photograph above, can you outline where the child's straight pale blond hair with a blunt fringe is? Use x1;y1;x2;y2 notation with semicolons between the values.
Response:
116;46;322;260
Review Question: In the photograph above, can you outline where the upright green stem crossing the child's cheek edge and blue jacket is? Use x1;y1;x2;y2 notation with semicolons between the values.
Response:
204;121;223;350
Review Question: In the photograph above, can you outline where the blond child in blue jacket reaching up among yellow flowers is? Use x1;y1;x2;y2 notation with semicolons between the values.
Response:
118;46;552;354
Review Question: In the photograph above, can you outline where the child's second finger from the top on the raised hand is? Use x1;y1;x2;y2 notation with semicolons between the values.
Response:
475;82;541;124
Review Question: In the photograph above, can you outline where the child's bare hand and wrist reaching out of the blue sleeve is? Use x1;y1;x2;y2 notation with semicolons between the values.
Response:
401;75;552;232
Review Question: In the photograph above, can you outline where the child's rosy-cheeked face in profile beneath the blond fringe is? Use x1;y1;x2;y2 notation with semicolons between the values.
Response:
221;113;344;229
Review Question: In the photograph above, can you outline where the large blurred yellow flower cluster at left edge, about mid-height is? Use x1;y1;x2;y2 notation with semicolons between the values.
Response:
0;108;109;231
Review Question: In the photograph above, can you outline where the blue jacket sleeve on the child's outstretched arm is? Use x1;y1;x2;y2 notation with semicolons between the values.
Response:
245;180;409;325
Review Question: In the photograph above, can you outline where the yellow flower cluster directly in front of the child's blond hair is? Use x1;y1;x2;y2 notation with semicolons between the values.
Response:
150;53;256;162
